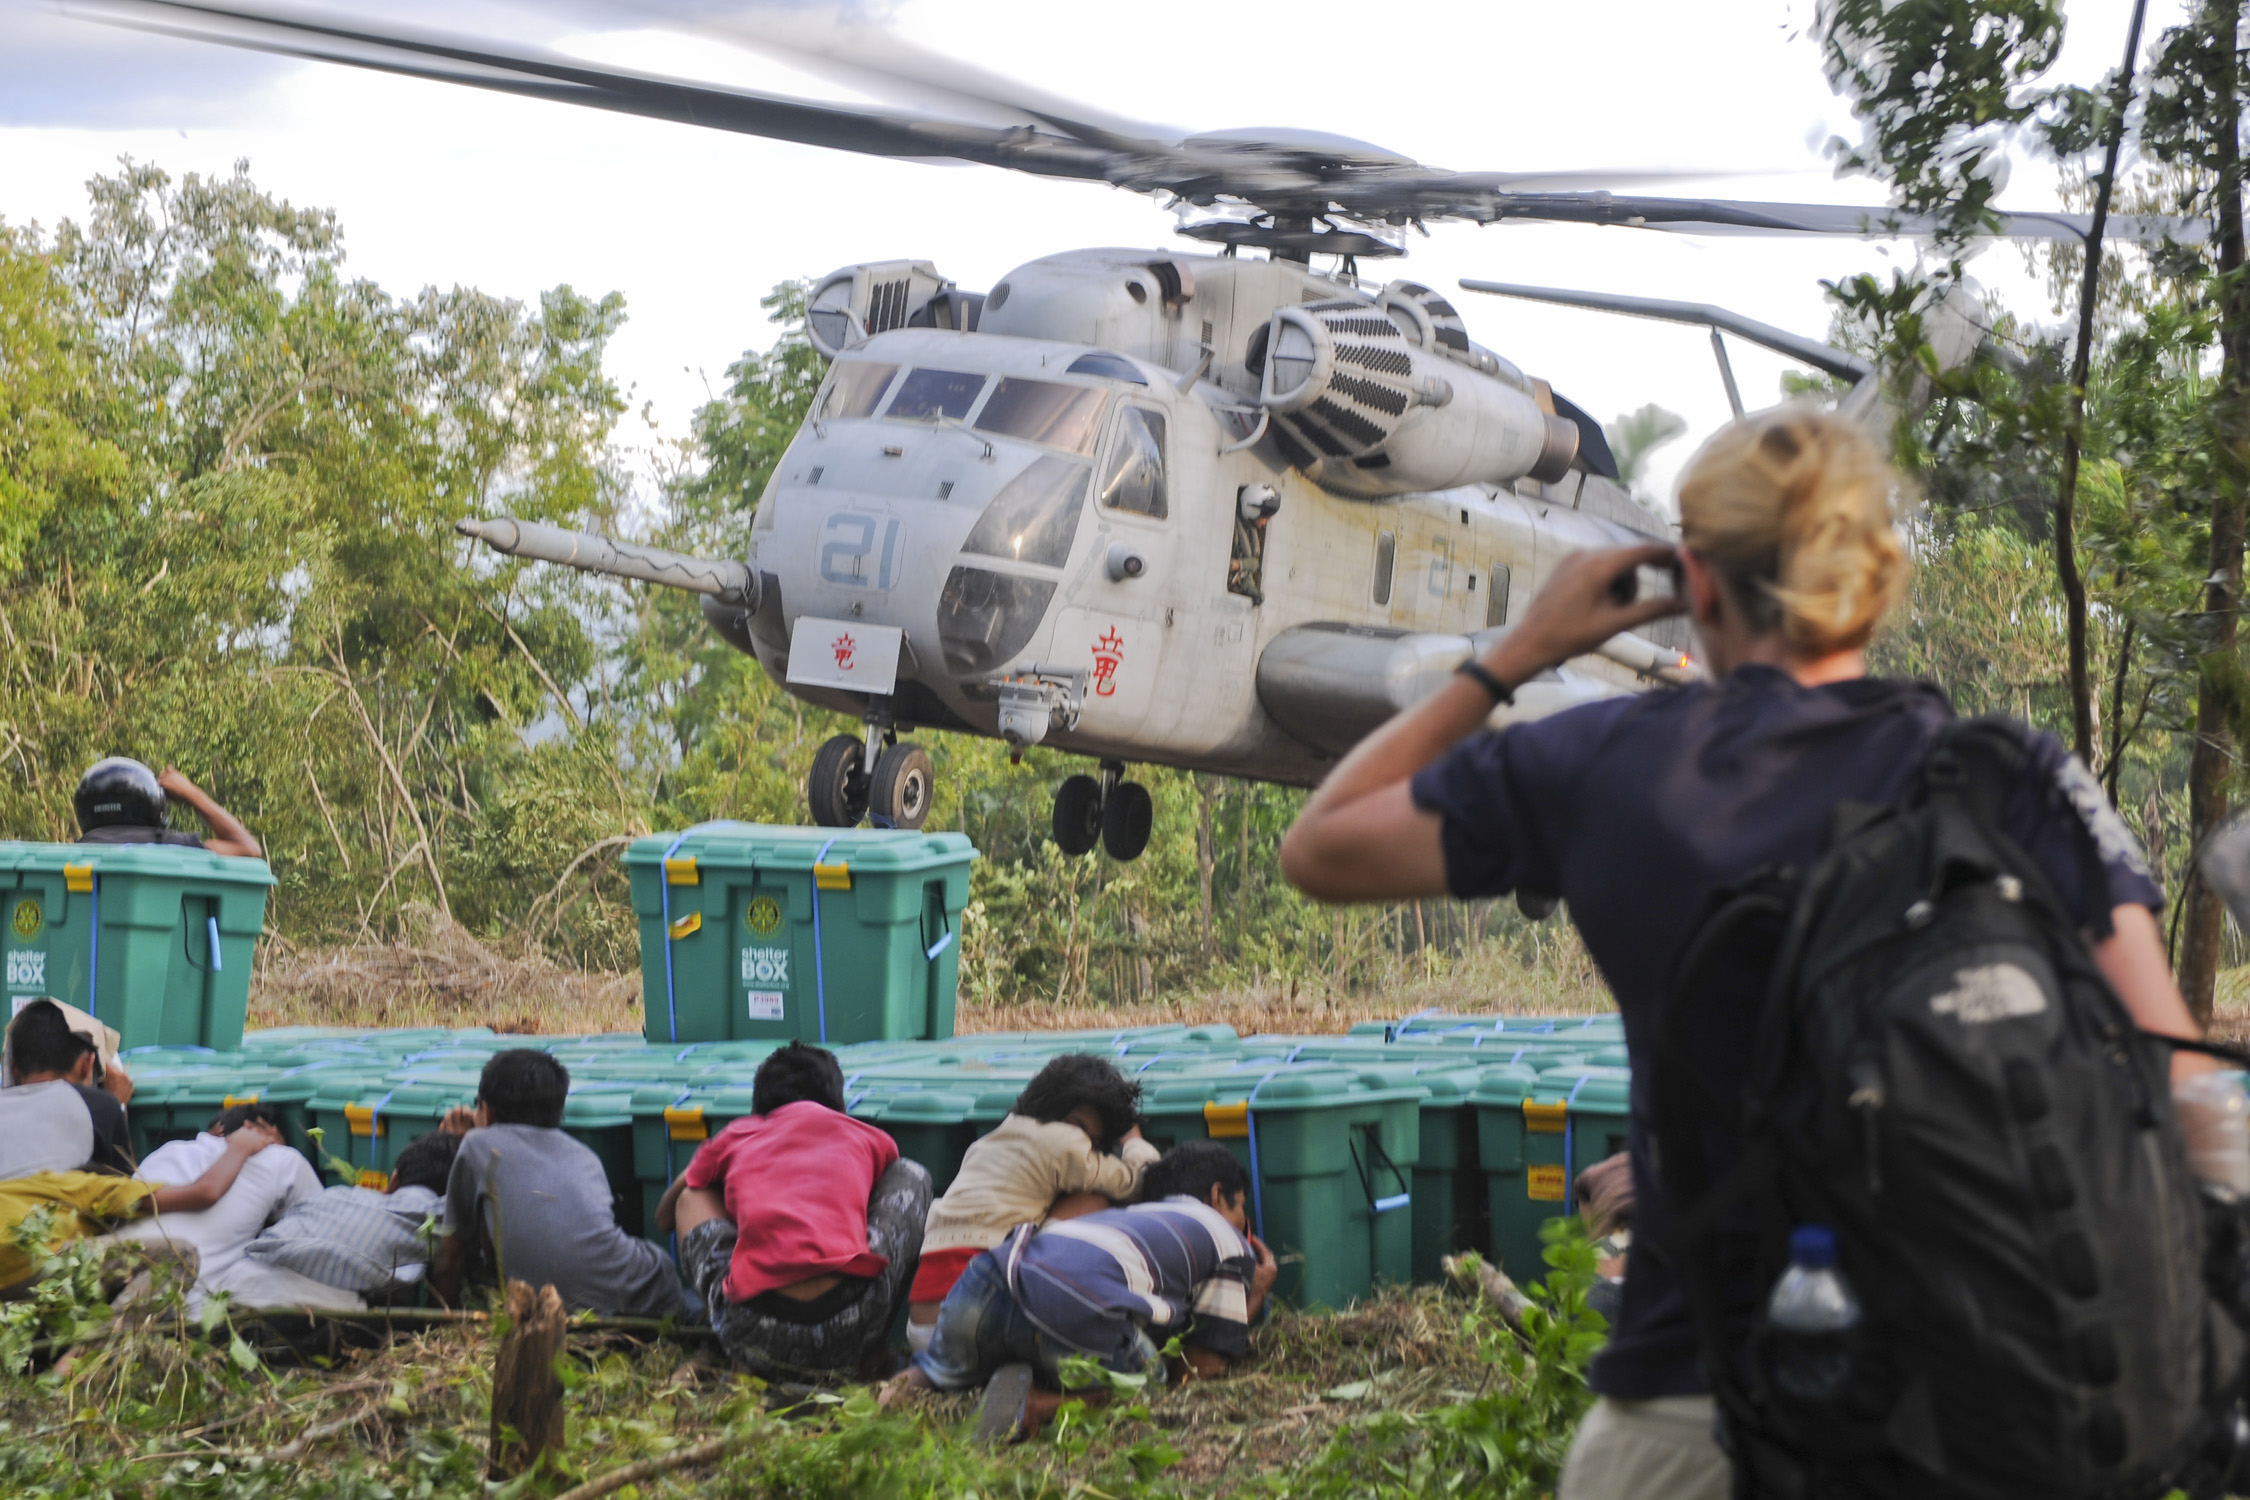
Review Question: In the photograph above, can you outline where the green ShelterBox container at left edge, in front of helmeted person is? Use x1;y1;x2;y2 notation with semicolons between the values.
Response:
0;843;275;1052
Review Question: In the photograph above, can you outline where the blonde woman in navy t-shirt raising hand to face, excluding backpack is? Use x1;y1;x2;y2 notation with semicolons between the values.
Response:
1283;409;2210;1500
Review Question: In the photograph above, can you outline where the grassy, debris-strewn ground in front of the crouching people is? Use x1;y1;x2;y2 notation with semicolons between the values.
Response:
0;1248;1591;1500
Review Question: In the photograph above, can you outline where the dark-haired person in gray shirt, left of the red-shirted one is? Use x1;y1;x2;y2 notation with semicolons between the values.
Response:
430;1048;686;1318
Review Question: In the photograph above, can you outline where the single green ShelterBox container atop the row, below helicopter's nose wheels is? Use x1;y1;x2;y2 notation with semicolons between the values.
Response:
626;823;977;1043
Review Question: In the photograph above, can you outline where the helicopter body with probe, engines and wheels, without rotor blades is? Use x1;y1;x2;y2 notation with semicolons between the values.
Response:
461;250;1685;857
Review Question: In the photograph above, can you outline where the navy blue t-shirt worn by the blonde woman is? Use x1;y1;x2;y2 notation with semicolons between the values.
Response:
1413;666;2162;1399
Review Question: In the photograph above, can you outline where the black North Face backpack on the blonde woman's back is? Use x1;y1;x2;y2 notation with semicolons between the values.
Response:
1654;720;2243;1500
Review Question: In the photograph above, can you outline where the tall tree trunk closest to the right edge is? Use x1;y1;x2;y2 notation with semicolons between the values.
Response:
2180;0;2250;1021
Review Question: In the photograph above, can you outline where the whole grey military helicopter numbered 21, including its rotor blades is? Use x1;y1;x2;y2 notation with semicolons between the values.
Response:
83;0;2194;859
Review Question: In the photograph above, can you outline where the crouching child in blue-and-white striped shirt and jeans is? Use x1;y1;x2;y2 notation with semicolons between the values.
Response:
884;1140;1276;1437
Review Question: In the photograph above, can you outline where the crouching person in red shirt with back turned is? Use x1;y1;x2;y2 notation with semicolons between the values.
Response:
657;1041;929;1381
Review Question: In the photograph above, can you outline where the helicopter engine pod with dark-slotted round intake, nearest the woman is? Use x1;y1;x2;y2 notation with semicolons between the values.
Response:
1258;299;1577;497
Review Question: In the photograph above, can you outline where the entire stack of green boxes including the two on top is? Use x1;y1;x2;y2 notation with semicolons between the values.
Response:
0;823;1629;1304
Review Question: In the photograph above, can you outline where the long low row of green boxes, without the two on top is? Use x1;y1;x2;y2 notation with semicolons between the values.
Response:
109;1021;1629;1307
